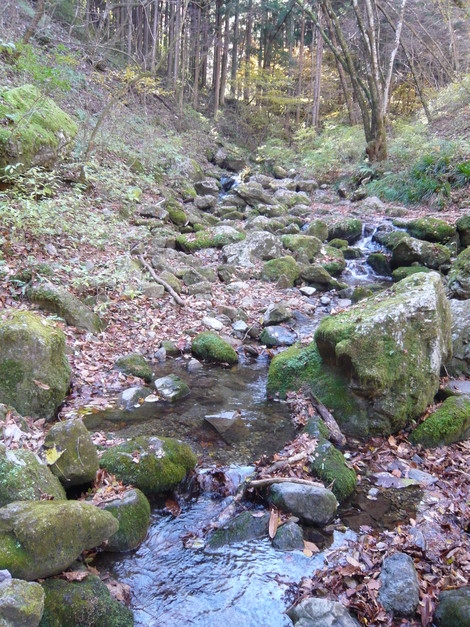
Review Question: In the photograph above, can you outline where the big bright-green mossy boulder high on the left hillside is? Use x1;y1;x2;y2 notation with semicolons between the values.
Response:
0;85;77;170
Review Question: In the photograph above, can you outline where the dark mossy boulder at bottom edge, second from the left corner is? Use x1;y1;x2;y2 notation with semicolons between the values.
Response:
39;575;134;627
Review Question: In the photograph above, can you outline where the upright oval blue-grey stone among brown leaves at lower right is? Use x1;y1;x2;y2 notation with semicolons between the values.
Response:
379;553;419;616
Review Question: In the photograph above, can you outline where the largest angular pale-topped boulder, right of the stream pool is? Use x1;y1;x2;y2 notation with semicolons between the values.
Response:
315;272;452;434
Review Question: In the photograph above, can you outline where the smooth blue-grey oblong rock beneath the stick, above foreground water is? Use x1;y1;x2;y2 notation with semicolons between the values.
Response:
268;483;338;526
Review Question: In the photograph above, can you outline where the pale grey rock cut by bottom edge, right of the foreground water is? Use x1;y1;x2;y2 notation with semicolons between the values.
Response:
289;598;359;627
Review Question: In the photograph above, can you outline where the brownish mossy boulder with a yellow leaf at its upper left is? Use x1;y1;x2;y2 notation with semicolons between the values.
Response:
44;418;99;488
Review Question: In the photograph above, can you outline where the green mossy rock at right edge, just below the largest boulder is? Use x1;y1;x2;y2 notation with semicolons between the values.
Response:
410;396;470;448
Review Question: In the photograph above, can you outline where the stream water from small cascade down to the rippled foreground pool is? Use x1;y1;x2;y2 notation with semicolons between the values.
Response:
93;227;410;627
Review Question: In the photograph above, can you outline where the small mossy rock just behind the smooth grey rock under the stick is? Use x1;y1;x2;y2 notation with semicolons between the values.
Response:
311;437;357;503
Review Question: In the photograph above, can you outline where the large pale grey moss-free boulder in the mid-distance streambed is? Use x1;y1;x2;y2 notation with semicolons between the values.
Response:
222;231;282;268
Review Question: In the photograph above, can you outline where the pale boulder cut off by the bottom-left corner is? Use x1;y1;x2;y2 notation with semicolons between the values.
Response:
0;577;44;627
